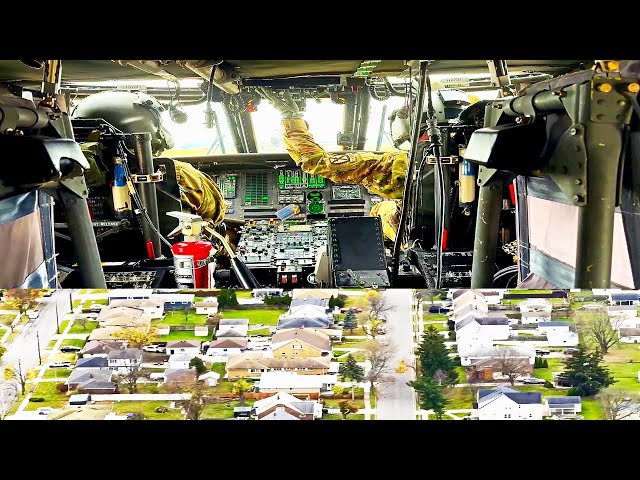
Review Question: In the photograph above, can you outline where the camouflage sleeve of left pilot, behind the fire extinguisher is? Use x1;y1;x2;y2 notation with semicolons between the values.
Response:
174;160;226;225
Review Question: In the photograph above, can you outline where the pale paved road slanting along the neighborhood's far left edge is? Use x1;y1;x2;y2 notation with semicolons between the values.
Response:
0;290;70;403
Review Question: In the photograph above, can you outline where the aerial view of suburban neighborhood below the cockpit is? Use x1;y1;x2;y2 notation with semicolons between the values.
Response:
0;288;640;421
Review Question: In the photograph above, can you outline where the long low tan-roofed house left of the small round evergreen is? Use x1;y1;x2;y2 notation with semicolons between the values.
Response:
226;352;331;379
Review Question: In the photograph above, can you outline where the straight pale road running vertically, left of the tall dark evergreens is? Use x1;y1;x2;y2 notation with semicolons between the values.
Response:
376;289;416;420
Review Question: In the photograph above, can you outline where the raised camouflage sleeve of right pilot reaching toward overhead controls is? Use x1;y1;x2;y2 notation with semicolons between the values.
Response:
282;118;407;199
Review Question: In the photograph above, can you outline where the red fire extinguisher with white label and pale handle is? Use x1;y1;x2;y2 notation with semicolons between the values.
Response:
167;212;215;288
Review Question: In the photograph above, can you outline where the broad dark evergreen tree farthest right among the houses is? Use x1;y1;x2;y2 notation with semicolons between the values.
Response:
559;344;617;397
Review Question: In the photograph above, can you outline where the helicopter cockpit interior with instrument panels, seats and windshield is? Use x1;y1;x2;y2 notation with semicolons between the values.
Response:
0;60;640;288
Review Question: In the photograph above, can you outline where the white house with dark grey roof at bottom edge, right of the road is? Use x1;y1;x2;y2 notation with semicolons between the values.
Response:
472;387;543;420
